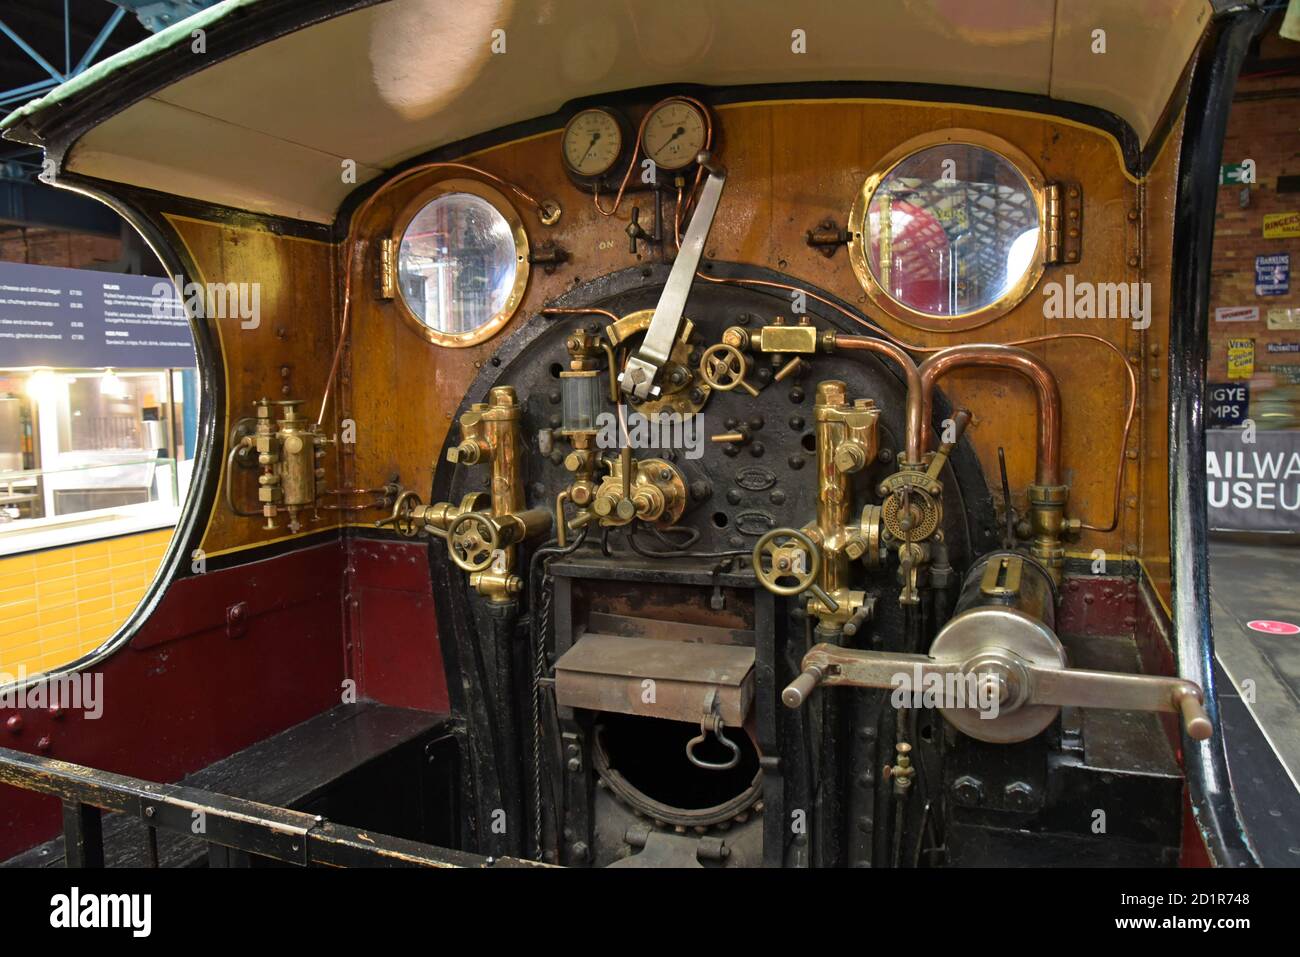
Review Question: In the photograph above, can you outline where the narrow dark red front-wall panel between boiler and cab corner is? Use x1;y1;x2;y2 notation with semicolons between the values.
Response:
348;538;450;713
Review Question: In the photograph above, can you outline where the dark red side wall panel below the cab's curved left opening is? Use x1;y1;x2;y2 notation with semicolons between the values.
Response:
0;542;345;859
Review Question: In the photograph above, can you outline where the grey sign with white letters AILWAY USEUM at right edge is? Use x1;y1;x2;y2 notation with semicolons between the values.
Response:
1205;429;1300;532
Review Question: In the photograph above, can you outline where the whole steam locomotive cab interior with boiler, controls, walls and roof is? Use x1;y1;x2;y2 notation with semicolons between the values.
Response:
3;0;1249;867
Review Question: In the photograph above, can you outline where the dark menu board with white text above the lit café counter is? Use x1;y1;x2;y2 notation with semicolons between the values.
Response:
0;263;195;369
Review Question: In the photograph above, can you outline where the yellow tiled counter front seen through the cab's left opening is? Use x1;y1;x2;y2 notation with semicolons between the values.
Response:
0;528;172;675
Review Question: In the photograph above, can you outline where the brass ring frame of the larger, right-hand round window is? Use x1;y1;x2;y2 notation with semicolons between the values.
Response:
849;129;1048;333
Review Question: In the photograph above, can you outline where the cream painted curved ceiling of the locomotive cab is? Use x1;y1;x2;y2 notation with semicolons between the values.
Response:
5;0;1210;222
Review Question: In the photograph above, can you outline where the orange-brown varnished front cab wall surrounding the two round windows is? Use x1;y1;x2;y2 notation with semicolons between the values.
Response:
348;100;1149;555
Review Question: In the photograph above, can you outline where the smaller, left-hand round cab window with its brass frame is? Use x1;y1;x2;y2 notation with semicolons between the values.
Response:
395;179;528;347
